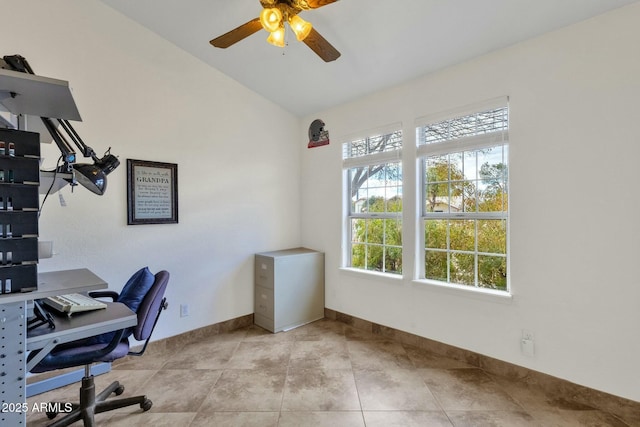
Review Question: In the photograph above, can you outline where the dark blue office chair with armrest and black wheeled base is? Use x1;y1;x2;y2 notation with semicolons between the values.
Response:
29;267;169;427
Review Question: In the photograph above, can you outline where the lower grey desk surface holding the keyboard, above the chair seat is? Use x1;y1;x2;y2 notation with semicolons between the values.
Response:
27;302;138;350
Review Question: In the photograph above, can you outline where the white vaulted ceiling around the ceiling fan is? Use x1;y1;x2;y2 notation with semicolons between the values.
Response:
101;0;638;116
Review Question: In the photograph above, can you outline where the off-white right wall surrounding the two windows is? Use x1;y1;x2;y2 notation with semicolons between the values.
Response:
302;3;640;401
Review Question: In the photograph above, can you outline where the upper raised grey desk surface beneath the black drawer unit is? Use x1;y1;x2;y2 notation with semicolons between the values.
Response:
0;268;108;304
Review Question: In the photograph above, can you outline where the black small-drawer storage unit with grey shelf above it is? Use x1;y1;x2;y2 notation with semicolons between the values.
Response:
0;67;81;300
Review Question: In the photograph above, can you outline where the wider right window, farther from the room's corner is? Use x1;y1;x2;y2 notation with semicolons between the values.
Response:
416;100;509;291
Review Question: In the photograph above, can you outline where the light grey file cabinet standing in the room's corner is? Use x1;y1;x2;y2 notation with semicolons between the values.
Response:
254;248;324;333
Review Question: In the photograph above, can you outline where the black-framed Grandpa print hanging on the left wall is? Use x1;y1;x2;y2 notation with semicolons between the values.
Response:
127;159;178;225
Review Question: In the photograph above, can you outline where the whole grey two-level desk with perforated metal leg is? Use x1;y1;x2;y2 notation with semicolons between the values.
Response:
0;269;131;426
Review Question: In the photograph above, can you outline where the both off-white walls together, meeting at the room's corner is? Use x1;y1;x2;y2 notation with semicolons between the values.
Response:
6;0;640;401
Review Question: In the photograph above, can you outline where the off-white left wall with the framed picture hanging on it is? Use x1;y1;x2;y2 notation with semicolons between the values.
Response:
0;0;300;339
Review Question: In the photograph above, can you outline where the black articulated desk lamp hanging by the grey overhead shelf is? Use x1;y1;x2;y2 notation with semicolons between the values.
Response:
3;55;120;196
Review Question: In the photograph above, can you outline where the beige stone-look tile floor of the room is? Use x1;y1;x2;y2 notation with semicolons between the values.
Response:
27;319;627;427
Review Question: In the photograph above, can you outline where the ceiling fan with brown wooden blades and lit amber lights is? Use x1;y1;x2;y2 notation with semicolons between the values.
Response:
209;0;340;62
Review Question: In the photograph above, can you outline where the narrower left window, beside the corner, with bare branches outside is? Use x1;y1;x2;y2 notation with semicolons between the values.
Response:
343;130;402;274
